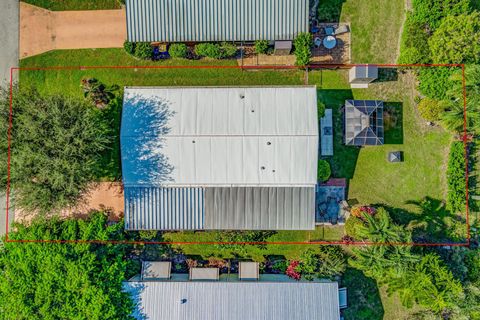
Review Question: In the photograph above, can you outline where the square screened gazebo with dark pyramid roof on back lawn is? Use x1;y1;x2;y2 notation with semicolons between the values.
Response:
345;100;384;146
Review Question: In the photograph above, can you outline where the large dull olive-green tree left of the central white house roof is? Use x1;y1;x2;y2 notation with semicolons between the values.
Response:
0;89;110;212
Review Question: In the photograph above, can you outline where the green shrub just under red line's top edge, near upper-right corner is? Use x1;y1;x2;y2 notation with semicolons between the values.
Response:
418;67;457;100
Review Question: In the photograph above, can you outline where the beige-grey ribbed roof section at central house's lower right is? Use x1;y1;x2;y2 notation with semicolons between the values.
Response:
205;187;315;230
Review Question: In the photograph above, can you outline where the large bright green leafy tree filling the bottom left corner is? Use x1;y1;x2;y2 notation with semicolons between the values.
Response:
0;213;137;320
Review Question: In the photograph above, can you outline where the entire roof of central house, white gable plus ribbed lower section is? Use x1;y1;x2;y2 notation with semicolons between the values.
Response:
121;86;319;230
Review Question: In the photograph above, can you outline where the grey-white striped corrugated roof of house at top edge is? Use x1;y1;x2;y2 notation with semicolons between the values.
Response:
126;0;309;42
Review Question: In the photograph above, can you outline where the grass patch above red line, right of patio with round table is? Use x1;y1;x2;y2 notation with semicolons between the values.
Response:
338;0;405;63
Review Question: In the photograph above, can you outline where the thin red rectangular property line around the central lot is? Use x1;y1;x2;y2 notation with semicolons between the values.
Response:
5;64;470;247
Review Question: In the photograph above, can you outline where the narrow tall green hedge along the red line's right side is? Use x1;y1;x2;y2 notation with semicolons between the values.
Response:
447;141;466;213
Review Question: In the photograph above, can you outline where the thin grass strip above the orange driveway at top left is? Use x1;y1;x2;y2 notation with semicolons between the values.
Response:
22;0;122;11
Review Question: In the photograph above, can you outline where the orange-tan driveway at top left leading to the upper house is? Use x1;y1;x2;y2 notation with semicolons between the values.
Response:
19;0;127;58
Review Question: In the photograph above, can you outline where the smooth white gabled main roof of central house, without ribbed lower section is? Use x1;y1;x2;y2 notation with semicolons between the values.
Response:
121;86;318;186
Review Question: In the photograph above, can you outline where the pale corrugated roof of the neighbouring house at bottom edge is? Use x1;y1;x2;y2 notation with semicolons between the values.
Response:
124;281;340;320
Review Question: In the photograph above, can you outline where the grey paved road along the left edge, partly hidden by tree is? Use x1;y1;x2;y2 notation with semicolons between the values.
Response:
0;0;19;236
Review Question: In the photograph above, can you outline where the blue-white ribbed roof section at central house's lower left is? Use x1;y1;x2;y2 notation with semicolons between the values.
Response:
124;187;205;230
